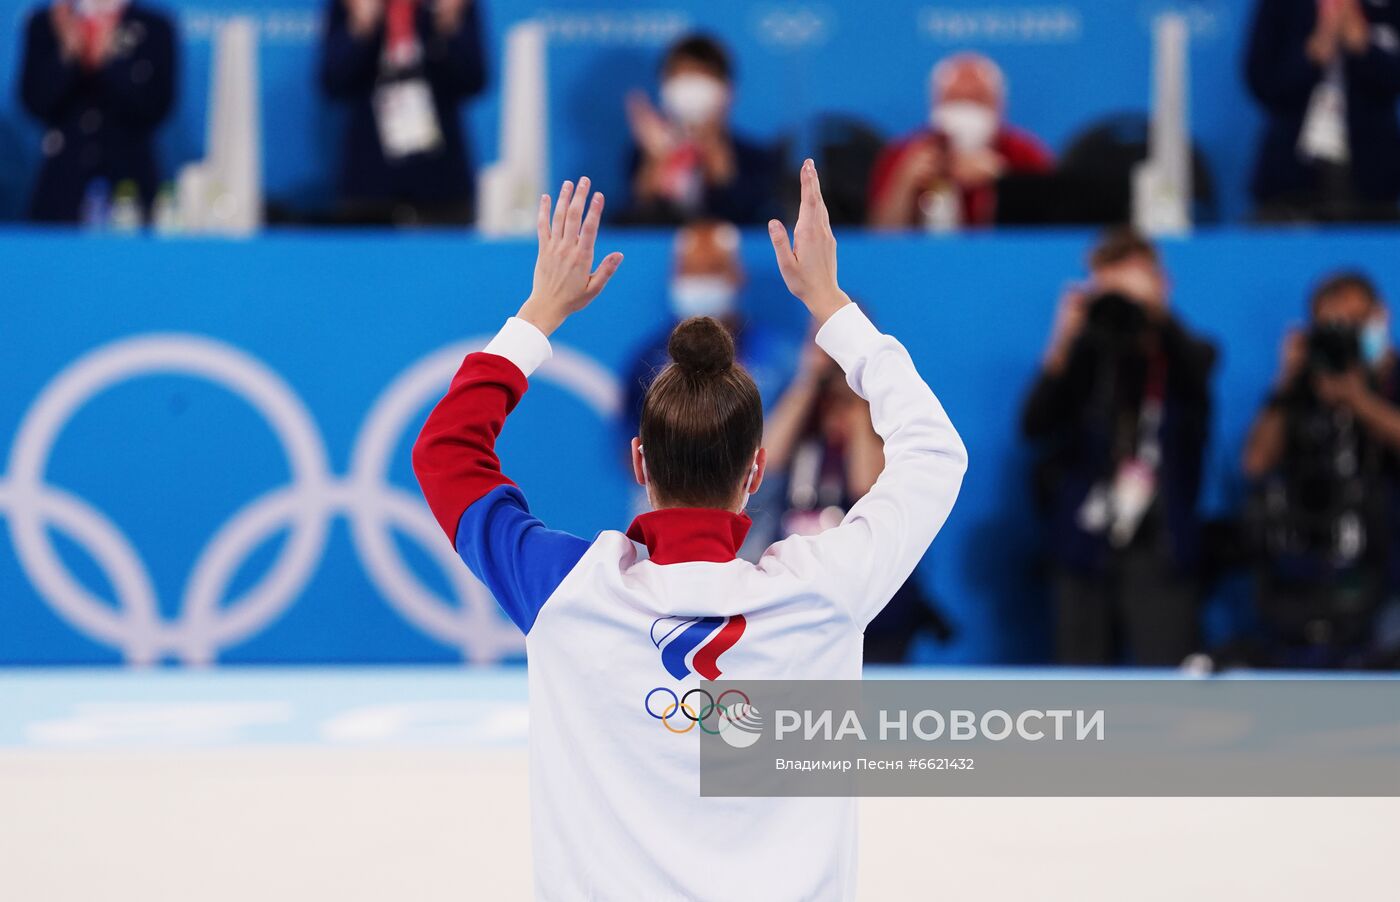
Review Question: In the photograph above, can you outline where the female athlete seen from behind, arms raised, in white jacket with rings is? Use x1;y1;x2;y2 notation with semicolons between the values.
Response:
413;161;967;902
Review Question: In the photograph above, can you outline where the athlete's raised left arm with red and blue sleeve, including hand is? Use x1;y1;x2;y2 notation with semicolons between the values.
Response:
413;179;622;633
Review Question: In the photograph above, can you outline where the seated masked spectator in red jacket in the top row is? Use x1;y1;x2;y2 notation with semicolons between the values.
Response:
869;53;1054;230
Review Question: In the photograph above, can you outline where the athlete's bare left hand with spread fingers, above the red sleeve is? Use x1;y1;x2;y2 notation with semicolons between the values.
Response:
517;176;622;335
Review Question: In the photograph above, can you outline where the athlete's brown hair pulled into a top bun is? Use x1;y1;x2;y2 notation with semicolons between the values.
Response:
640;317;763;508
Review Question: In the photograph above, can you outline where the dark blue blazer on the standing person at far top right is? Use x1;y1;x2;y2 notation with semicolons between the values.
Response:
1246;0;1400;202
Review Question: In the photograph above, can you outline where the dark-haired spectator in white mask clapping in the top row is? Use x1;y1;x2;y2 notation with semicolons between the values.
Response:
619;35;780;226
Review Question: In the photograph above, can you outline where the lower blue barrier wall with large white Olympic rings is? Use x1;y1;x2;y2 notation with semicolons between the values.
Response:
0;225;1400;664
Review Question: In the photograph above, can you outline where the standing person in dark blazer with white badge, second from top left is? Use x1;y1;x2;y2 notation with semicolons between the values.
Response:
321;0;486;223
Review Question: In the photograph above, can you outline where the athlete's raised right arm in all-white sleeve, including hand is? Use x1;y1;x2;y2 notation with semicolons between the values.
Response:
763;160;967;627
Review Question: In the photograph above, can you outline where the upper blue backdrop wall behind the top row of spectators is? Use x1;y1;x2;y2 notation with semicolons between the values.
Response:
0;0;1259;218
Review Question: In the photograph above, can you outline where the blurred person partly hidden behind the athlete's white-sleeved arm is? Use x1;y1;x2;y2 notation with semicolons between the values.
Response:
755;334;952;664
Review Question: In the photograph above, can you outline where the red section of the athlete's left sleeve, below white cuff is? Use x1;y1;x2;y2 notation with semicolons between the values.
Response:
413;353;528;545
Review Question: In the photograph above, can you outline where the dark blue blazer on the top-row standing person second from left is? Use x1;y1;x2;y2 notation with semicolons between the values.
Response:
321;0;486;206
